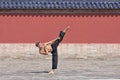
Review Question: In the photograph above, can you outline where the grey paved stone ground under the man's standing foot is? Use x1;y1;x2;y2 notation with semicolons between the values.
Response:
0;57;120;80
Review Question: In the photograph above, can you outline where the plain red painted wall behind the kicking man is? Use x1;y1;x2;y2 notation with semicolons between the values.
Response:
0;14;120;43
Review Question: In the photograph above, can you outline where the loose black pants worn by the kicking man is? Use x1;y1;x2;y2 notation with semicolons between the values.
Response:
51;31;65;69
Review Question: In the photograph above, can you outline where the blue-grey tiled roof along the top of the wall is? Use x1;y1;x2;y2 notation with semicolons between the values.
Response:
0;0;120;9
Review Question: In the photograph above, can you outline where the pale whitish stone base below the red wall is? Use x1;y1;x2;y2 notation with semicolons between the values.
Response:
0;43;120;59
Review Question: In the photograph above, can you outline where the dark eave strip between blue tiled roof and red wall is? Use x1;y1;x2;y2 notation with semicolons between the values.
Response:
0;9;120;13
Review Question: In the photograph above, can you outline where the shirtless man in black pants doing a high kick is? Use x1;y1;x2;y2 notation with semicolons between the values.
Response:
35;26;70;74
